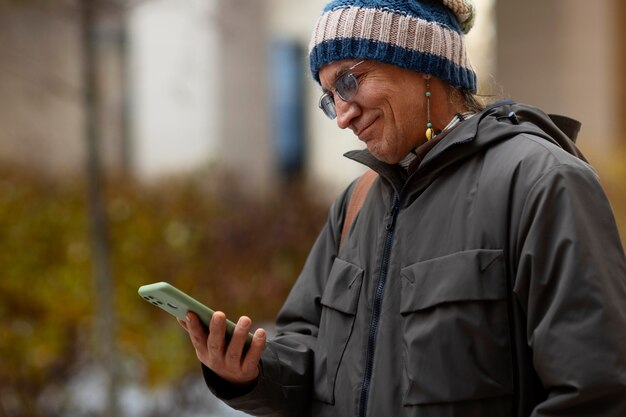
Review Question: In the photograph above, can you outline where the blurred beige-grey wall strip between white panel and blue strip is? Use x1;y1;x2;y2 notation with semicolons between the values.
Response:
216;0;276;192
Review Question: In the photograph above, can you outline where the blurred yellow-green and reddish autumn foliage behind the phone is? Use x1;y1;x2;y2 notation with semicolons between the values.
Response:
0;165;327;416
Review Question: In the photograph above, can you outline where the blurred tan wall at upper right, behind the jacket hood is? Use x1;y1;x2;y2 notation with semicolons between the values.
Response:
496;0;623;152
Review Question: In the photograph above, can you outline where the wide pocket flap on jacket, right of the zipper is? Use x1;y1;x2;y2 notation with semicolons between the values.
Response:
400;249;506;313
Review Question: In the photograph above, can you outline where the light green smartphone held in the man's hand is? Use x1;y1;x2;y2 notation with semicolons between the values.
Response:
138;282;252;351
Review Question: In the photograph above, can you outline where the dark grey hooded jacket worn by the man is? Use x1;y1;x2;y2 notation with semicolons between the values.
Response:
204;102;626;417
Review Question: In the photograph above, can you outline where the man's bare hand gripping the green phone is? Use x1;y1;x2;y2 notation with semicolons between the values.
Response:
178;311;266;385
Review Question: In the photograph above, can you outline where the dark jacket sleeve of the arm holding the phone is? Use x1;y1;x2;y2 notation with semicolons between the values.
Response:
203;188;350;416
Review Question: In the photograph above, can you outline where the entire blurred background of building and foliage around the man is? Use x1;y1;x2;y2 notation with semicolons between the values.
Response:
0;0;626;417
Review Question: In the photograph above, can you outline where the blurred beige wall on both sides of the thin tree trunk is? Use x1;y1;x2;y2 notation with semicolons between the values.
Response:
0;3;125;175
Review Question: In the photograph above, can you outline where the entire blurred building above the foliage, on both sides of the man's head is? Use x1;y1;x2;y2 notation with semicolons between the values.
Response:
0;0;626;197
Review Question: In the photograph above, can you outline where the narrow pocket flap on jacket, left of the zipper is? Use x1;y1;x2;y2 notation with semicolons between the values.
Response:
322;258;363;314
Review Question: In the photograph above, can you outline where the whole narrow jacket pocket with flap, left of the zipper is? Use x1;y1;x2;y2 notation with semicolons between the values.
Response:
313;258;363;404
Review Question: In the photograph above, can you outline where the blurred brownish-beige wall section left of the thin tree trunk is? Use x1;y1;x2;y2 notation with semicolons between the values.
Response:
0;9;83;176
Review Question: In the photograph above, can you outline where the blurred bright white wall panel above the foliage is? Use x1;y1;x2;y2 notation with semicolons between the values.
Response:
126;0;223;182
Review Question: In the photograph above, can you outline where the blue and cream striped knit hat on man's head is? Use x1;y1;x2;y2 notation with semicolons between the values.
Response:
309;0;476;92
